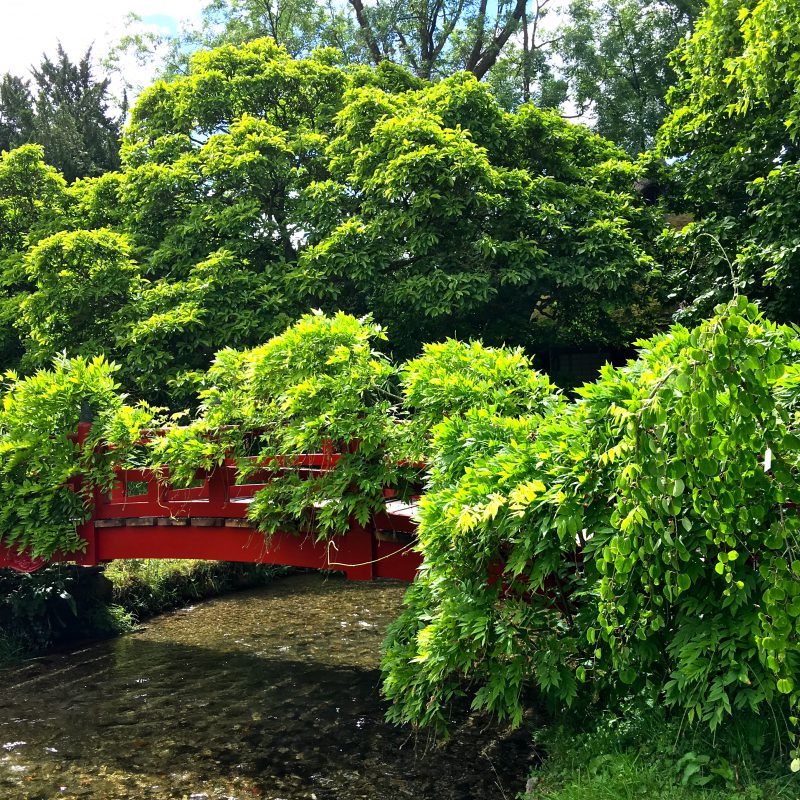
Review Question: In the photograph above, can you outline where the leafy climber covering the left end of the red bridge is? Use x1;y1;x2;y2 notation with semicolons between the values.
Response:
0;357;158;558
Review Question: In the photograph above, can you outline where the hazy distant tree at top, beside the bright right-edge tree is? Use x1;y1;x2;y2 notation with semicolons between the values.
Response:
557;0;703;155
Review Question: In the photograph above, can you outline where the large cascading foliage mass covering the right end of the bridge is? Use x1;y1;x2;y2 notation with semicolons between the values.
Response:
384;298;800;756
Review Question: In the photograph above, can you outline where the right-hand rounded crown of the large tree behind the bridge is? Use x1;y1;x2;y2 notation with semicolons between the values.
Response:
299;70;663;355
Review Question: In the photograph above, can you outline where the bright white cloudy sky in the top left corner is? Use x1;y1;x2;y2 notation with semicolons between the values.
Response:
0;0;205;76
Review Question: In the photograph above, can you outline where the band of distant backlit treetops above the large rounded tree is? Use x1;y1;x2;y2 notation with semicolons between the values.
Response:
115;0;704;147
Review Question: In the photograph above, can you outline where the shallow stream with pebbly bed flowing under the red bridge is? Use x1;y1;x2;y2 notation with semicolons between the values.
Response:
0;575;530;800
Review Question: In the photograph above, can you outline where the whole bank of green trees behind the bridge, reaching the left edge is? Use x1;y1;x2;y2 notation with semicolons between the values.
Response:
0;39;671;407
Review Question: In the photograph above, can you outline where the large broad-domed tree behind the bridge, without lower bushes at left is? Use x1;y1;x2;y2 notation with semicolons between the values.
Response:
124;40;663;384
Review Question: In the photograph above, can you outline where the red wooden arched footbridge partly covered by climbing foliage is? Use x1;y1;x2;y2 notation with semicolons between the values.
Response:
0;424;420;581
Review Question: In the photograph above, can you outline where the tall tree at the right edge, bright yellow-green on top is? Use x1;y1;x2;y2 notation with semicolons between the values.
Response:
660;0;800;321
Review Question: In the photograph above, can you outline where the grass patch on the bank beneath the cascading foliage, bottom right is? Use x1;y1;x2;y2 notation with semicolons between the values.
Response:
524;708;800;800
